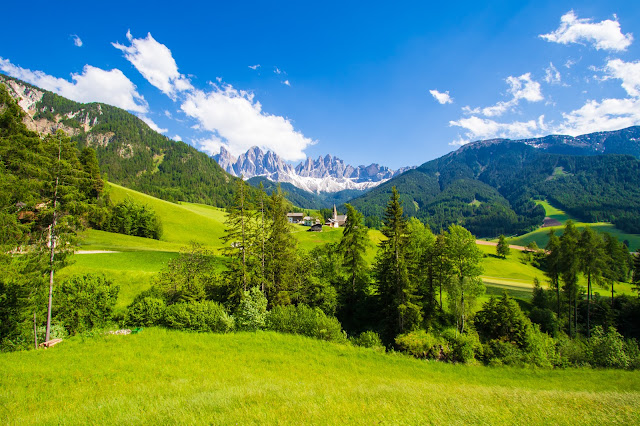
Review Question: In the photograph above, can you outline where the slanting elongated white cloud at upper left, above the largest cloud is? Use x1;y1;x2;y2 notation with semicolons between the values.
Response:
111;32;193;99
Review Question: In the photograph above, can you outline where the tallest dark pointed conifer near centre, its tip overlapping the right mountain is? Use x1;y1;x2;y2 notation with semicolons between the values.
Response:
375;187;422;340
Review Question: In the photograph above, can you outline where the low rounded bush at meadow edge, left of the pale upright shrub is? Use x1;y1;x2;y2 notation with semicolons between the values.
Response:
164;300;234;333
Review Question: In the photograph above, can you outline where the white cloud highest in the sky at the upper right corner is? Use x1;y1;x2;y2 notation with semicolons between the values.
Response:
540;10;633;51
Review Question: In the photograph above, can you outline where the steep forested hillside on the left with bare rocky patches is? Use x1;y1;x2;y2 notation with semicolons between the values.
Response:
0;74;246;207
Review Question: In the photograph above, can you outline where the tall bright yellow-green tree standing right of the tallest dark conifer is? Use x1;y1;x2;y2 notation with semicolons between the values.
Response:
446;225;484;333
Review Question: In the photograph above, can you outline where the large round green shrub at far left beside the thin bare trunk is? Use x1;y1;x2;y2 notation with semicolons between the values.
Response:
54;274;119;334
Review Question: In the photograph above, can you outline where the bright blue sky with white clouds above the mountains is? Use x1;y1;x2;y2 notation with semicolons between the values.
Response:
0;1;640;168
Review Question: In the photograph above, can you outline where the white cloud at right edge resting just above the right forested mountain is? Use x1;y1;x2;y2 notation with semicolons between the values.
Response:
554;99;640;136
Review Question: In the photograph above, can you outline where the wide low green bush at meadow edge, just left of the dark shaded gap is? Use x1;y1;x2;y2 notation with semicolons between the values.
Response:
266;305;347;343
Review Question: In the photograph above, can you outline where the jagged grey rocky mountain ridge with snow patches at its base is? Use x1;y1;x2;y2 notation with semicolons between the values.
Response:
213;146;411;193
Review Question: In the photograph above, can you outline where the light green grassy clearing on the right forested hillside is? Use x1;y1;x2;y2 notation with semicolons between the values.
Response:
508;201;640;251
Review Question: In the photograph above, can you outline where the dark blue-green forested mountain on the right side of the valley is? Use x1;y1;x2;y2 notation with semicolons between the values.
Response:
352;136;640;237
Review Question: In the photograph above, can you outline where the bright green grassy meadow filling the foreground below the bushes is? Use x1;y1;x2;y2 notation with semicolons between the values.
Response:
0;329;640;424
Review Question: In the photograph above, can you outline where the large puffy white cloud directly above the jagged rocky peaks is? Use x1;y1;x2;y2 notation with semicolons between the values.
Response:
181;84;314;161
